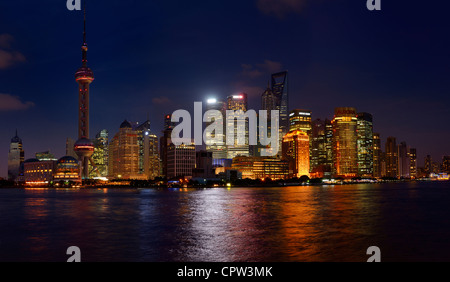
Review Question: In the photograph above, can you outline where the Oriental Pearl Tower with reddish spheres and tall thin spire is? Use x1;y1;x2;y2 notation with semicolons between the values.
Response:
74;2;94;179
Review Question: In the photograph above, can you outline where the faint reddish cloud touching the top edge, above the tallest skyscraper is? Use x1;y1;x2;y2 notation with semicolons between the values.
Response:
257;0;307;18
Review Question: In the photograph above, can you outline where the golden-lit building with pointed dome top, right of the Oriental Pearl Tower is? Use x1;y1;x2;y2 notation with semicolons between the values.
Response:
108;120;143;179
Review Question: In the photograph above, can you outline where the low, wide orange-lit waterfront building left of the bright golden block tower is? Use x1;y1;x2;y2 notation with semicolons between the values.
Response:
232;156;289;180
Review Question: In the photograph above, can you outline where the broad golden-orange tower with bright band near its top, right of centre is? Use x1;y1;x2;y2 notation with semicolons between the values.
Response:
332;107;358;178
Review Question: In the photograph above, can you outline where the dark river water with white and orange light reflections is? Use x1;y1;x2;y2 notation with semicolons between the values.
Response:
0;182;450;262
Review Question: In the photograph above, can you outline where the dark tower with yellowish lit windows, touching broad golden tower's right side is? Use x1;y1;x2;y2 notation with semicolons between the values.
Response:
356;113;374;177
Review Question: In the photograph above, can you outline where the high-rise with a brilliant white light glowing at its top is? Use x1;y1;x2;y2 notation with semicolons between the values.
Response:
205;98;227;160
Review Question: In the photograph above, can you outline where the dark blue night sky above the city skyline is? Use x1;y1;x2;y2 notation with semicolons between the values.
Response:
0;0;450;177
